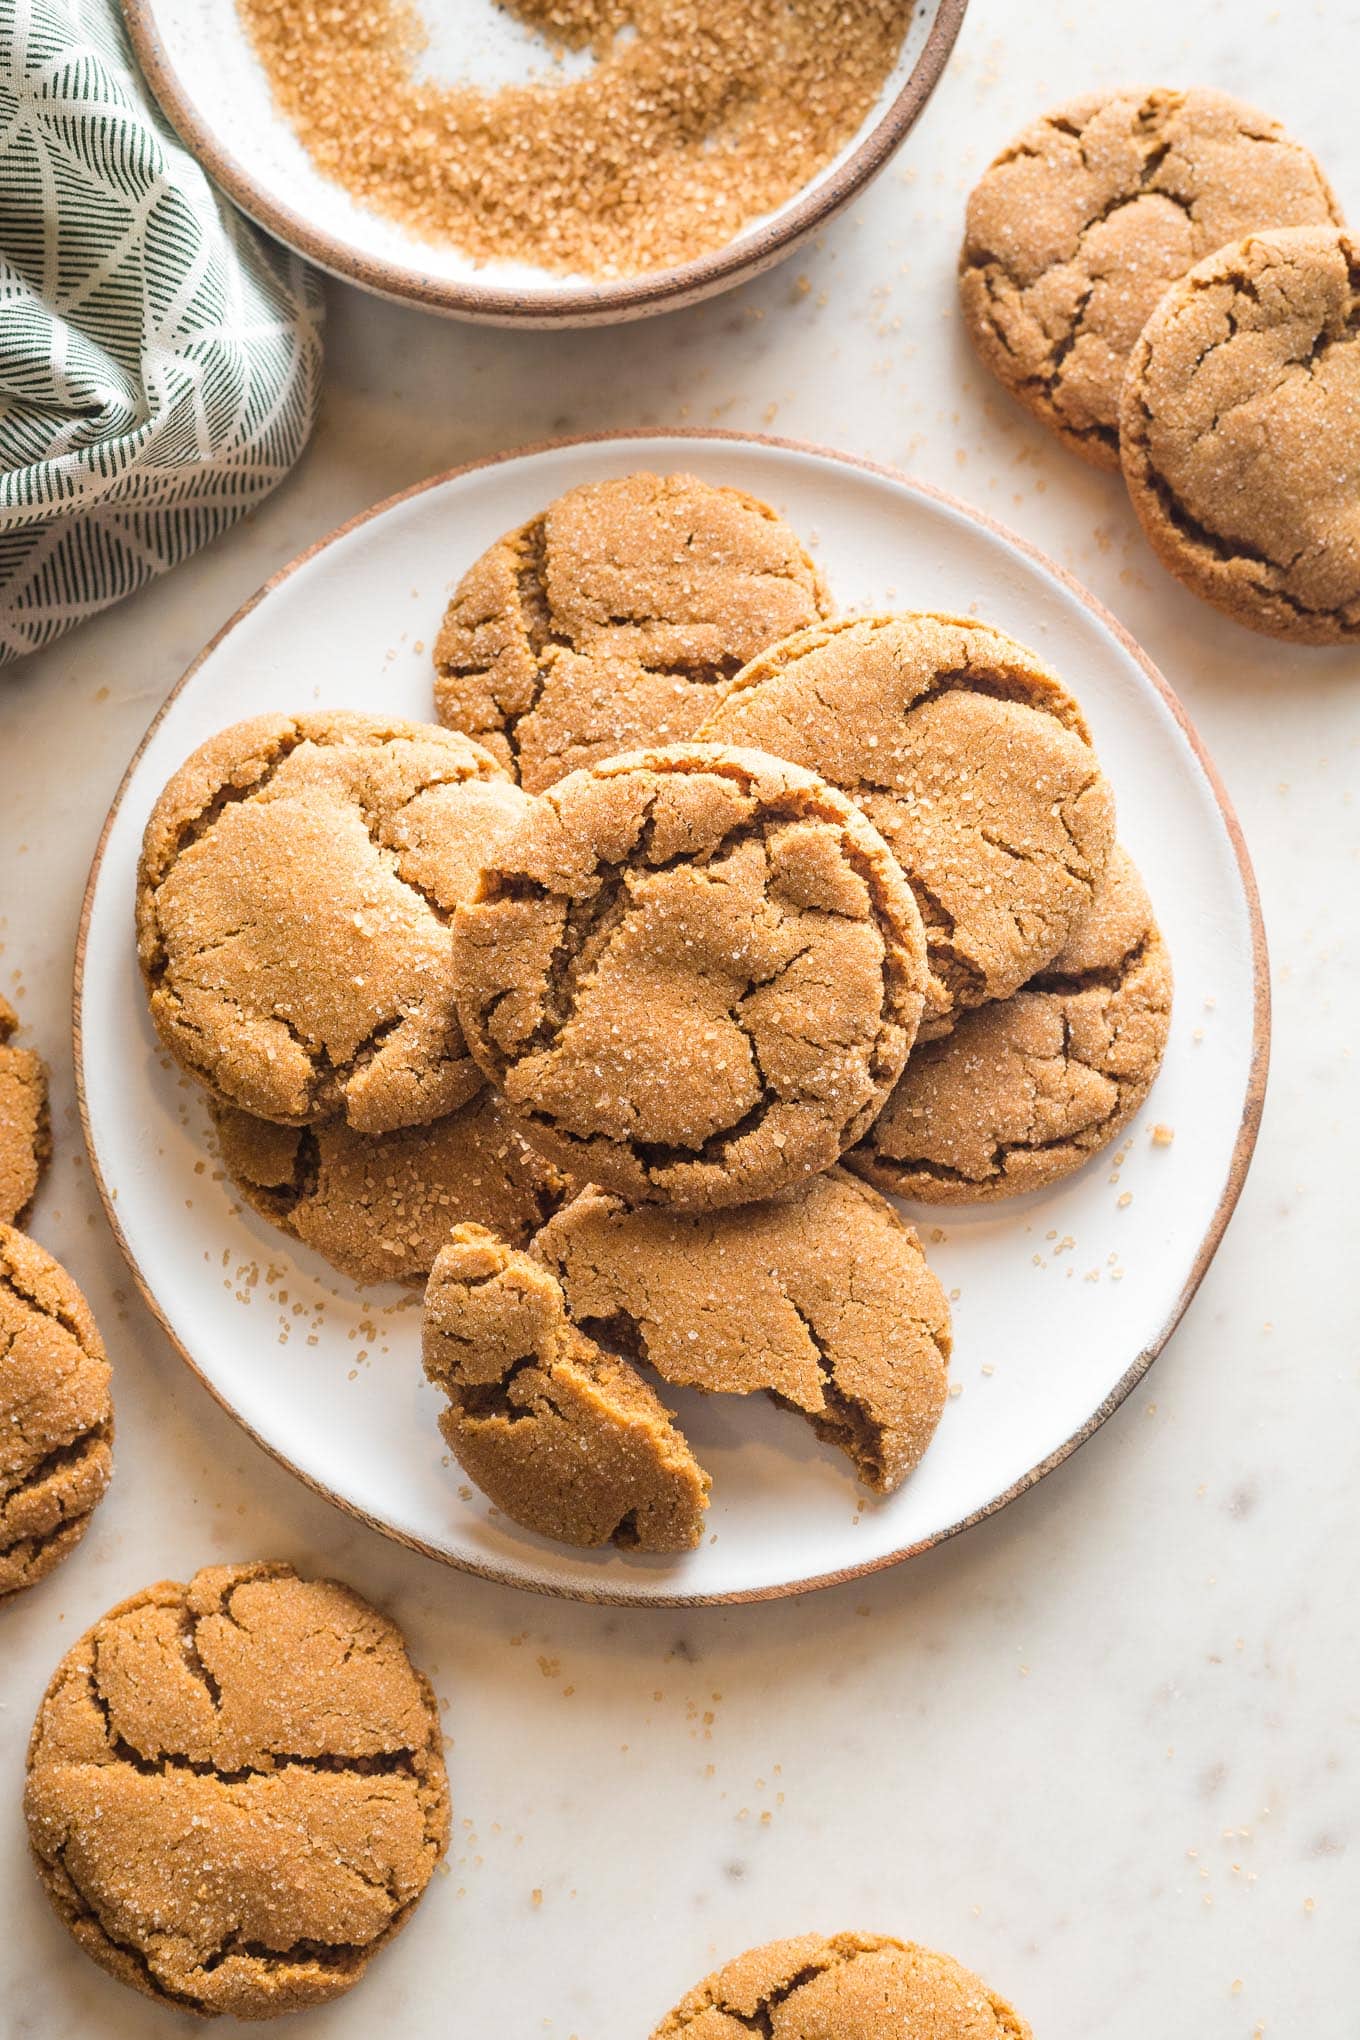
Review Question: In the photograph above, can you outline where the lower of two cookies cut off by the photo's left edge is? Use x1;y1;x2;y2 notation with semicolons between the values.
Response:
0;1226;114;1601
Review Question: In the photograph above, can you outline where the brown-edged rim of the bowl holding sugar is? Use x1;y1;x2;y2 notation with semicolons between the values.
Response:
122;0;969;326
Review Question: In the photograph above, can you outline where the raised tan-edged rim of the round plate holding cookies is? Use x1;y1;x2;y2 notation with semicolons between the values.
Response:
71;426;1270;1608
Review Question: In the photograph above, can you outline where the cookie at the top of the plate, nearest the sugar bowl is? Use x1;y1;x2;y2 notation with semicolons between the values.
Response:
434;473;830;794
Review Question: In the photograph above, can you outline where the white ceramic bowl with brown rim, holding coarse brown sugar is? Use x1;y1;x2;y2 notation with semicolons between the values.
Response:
122;0;969;326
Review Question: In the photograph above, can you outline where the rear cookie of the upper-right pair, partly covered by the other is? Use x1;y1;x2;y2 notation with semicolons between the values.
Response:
958;90;1340;467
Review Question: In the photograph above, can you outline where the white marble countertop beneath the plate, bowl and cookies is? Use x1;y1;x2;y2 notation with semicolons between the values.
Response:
0;0;1360;2040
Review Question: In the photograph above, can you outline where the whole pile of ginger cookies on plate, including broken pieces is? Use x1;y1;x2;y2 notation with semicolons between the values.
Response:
137;473;1170;1550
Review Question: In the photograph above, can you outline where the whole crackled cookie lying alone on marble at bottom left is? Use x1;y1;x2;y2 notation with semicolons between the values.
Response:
24;1565;449;2020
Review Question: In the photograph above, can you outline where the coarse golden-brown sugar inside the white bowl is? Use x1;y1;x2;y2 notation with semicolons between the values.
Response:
237;0;911;277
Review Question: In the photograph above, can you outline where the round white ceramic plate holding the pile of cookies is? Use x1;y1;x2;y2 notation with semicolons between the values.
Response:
75;435;1268;1601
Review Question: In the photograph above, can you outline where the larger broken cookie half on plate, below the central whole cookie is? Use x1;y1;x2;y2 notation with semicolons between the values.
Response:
532;1169;950;1493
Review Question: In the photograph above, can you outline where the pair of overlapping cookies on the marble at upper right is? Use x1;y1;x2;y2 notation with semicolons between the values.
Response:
960;90;1360;645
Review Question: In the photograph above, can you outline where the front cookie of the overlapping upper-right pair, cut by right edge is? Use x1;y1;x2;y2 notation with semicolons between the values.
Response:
1121;228;1360;645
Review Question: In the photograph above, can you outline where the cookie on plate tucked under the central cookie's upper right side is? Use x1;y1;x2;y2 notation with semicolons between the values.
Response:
699;612;1115;1040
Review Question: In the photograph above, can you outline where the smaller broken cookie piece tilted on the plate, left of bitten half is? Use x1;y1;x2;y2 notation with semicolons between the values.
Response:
424;1226;710;1550
